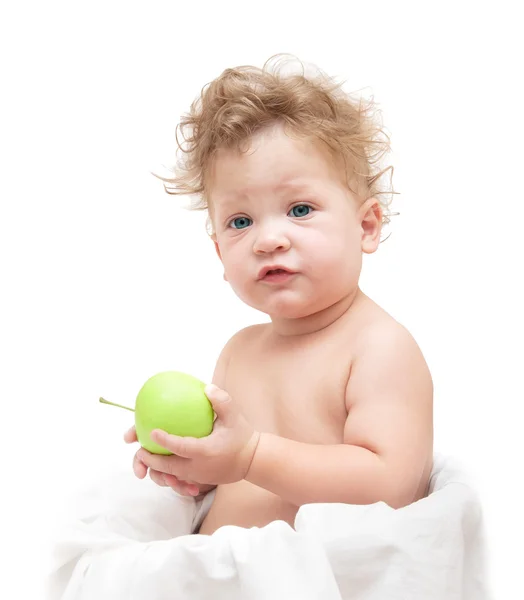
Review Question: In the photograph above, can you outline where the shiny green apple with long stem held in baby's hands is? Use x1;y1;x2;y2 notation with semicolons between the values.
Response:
100;371;215;454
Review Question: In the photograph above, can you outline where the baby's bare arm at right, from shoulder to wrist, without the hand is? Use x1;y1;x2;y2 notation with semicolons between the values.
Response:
246;321;433;508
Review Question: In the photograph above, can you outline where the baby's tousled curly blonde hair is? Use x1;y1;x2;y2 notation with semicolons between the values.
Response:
153;54;398;234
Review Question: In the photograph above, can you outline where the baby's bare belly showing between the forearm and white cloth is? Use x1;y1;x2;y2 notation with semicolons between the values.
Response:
199;481;298;535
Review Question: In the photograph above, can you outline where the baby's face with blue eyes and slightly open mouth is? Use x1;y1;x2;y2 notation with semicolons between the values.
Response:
209;127;378;318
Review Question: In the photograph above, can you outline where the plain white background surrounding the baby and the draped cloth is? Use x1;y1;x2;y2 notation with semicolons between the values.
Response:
0;0;524;598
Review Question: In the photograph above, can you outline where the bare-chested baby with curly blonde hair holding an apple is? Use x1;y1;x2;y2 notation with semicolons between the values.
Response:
125;55;433;534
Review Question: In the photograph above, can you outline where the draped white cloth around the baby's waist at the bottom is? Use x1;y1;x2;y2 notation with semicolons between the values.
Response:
47;456;491;600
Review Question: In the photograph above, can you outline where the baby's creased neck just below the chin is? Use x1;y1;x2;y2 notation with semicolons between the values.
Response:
271;287;364;337
